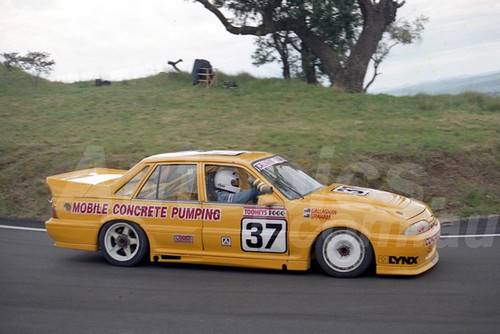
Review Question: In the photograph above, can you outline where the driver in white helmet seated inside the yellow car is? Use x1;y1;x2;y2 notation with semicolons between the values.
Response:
214;168;273;203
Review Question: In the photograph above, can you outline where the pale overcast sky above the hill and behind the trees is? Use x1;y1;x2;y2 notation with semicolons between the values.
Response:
0;0;500;92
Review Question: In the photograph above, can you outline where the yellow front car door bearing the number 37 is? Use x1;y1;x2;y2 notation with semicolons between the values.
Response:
203;164;288;259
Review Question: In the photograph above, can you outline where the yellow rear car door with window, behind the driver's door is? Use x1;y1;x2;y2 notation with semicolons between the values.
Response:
132;163;202;253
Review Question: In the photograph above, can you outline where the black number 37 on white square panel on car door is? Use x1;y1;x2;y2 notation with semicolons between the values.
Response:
241;218;286;253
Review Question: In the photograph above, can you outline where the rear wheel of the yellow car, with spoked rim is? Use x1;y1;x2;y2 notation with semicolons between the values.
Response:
99;221;149;267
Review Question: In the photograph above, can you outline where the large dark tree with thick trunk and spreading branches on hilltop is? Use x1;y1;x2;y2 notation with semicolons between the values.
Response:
196;0;405;92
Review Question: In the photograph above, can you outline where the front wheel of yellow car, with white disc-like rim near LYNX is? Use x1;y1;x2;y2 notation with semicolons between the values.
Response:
315;228;373;278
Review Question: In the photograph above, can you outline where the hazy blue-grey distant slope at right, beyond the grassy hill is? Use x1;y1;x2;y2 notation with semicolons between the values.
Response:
371;72;500;96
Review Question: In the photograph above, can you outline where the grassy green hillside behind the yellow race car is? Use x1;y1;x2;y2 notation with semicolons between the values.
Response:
0;68;500;220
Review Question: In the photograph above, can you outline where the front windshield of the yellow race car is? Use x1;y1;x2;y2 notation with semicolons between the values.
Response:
253;156;323;200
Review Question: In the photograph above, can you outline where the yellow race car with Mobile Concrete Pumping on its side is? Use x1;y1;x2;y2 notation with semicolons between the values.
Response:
46;151;440;277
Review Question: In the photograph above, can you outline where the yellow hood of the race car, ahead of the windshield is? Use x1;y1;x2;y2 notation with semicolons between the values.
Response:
309;184;426;220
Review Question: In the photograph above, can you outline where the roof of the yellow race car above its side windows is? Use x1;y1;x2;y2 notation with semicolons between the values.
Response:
143;150;273;162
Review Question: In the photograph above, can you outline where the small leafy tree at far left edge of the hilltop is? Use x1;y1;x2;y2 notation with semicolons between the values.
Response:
2;51;55;84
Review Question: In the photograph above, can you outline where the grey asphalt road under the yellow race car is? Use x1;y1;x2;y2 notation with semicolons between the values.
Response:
0;219;500;333
